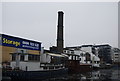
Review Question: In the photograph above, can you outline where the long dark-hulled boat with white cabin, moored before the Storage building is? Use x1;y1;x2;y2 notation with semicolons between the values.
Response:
2;53;68;80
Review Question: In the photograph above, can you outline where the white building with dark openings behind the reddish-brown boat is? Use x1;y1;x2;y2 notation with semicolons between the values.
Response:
63;45;100;67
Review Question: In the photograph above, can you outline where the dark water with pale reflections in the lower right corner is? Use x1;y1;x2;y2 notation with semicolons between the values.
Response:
44;68;120;81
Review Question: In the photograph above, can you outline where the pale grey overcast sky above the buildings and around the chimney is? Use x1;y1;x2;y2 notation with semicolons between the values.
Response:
0;2;118;49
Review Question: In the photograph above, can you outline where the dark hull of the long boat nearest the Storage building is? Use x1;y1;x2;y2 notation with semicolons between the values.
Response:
2;68;68;80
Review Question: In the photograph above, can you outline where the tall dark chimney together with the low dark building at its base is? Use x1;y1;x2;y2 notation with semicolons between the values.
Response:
50;11;64;53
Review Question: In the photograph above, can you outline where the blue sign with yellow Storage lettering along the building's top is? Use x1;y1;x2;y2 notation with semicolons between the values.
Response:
0;34;41;51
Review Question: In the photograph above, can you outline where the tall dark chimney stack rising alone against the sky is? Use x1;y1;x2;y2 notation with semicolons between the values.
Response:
57;11;64;53
